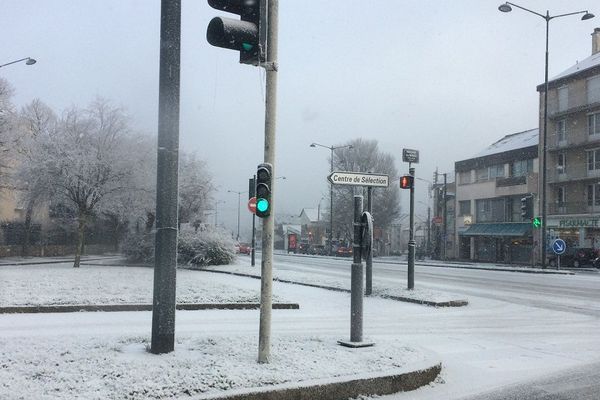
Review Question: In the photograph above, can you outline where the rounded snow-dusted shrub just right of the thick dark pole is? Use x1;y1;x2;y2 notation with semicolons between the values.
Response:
177;227;235;266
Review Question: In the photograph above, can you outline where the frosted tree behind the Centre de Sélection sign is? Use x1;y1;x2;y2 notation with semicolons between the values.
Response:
325;139;400;240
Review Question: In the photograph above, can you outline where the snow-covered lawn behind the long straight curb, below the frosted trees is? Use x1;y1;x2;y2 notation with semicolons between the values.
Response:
0;262;281;307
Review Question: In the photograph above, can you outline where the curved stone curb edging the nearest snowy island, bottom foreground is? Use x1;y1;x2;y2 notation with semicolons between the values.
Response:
199;363;442;400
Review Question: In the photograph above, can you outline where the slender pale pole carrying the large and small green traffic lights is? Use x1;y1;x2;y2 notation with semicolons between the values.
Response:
258;0;279;363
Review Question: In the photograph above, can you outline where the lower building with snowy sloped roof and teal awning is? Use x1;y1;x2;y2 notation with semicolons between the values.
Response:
455;129;539;264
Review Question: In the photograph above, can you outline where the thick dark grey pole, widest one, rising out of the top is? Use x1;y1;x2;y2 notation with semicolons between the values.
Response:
150;0;181;354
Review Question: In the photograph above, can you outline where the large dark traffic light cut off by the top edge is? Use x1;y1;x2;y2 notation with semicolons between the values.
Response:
206;0;266;65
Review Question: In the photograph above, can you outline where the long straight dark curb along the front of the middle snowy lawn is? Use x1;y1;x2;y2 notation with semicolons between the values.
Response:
0;303;300;314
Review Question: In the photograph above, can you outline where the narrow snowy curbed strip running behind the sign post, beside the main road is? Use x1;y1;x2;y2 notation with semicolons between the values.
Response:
202;265;469;307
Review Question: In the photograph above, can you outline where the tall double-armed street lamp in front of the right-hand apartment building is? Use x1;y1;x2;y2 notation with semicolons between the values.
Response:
498;1;594;268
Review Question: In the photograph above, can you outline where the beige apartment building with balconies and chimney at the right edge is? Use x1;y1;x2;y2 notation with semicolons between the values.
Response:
537;28;600;249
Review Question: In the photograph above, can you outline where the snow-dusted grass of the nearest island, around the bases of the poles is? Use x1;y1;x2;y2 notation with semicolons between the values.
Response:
0;336;424;400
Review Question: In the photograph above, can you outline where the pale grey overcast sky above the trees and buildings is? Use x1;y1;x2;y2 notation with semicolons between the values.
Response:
0;0;600;238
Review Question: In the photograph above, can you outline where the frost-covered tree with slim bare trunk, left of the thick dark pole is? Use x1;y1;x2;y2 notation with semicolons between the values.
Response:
20;99;133;268
